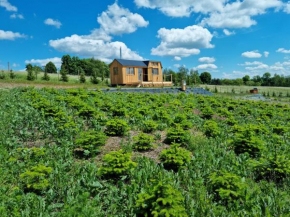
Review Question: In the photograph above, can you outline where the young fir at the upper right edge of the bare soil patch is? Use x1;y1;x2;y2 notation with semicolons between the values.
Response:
166;125;189;145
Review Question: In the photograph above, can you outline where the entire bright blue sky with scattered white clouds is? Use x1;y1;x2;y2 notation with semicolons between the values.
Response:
0;0;290;79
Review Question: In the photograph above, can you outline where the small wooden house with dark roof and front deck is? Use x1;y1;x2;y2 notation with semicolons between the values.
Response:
110;59;172;87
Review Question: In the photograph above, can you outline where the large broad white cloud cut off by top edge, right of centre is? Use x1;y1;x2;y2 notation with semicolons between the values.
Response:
134;0;282;28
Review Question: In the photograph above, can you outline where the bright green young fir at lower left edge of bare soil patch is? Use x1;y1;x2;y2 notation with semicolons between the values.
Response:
98;149;137;178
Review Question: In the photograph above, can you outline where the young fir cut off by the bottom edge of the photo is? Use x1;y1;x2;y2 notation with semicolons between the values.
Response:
136;181;188;217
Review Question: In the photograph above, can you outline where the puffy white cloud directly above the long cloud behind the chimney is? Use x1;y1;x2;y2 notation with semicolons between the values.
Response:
98;3;149;35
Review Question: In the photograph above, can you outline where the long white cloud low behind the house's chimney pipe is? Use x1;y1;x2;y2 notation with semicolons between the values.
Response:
49;35;143;62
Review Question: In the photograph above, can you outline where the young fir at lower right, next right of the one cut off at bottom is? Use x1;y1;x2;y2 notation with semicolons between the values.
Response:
209;172;247;203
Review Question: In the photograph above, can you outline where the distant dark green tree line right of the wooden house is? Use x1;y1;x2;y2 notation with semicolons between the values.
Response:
163;66;290;87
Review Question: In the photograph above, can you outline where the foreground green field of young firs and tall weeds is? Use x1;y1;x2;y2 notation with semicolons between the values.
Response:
0;88;290;217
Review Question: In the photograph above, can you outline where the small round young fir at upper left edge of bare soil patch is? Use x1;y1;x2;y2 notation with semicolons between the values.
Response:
105;119;130;136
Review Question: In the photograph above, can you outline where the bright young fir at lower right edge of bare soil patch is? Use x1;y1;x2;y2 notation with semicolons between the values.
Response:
159;144;191;171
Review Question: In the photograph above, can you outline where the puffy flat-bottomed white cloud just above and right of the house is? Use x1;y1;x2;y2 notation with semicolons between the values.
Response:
151;25;214;57
